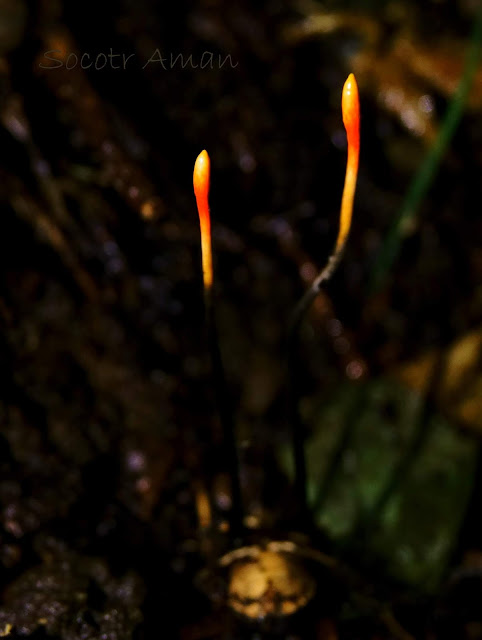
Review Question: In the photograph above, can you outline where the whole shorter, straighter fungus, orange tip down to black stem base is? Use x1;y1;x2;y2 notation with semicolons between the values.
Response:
193;151;242;534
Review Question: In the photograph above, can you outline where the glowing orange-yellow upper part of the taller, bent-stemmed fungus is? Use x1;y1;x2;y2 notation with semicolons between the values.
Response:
335;73;360;252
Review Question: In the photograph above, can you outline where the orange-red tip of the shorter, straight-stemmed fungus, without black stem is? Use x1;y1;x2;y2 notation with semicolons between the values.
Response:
193;150;213;291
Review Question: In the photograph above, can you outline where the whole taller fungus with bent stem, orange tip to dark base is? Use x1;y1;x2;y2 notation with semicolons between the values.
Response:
288;73;360;510
